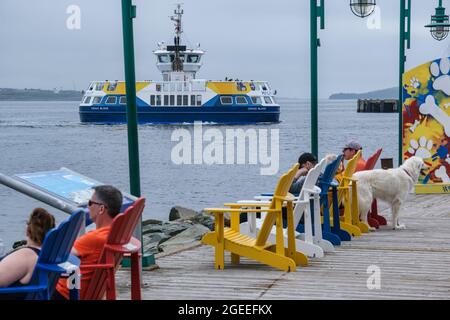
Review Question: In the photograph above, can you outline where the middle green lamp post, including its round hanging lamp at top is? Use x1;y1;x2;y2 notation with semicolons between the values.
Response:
310;0;376;157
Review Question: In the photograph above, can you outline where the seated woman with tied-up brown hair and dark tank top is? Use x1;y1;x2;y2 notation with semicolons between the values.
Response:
0;208;55;300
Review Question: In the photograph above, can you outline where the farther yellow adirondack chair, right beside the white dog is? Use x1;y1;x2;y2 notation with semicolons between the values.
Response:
330;150;369;236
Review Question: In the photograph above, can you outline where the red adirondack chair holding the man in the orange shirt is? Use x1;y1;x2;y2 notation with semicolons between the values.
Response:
80;198;145;300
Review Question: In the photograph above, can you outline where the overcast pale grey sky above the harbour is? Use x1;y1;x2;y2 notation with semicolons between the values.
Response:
0;0;450;97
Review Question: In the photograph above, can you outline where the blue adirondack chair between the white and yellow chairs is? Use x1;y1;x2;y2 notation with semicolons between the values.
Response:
319;155;352;245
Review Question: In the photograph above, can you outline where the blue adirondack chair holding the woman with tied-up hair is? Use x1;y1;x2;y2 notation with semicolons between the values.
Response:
0;210;85;300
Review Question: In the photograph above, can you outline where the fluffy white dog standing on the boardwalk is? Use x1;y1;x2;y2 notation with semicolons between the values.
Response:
353;156;425;229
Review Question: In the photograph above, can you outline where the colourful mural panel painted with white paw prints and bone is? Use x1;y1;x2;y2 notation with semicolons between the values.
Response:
403;58;450;192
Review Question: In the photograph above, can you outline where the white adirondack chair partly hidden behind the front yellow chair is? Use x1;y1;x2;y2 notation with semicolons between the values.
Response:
238;159;334;258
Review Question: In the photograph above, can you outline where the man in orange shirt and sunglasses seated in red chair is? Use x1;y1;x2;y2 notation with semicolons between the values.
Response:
53;185;123;300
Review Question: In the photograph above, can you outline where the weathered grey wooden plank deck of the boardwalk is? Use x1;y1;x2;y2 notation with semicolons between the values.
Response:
117;195;450;300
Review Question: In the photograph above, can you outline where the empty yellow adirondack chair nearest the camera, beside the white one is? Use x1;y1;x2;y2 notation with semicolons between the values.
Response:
202;164;308;271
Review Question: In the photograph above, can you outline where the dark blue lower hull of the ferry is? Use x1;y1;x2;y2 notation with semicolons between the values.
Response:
80;106;280;124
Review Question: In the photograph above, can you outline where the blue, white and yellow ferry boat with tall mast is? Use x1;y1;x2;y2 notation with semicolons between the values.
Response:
79;4;280;124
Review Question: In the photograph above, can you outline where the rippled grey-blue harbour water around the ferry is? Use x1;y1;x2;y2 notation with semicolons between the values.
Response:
0;99;398;247
